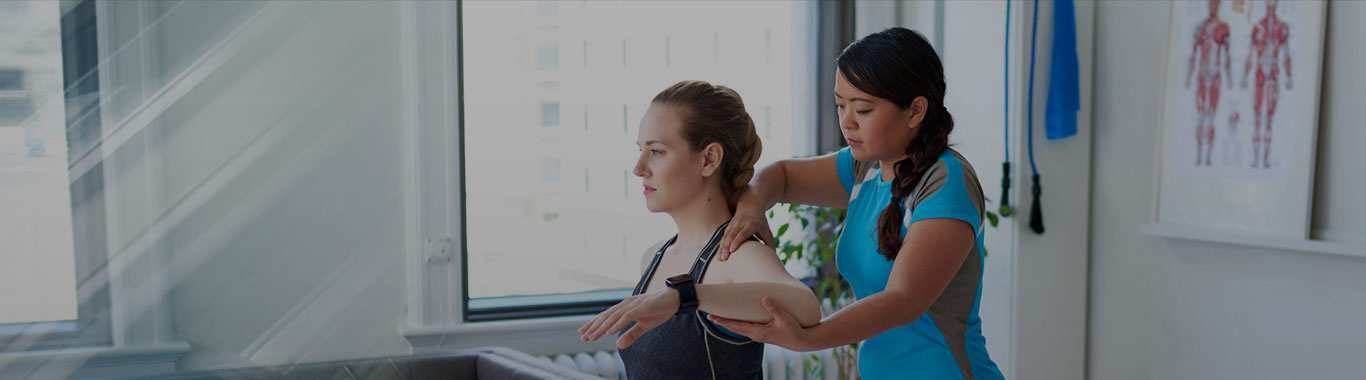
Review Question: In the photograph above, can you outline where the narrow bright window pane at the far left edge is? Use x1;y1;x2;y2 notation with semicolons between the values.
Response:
0;1;76;326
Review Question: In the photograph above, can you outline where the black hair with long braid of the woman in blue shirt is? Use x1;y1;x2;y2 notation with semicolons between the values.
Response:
835;27;953;260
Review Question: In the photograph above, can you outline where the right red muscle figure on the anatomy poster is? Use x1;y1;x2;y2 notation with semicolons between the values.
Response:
1242;0;1292;168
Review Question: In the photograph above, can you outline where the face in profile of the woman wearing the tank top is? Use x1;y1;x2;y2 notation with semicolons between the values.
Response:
631;104;716;212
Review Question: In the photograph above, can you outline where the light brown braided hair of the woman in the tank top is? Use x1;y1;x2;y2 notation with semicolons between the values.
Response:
653;81;764;213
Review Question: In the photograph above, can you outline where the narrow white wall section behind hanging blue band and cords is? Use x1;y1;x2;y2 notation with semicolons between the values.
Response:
1011;0;1104;380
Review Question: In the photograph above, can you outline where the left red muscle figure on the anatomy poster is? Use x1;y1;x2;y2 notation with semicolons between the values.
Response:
1186;0;1234;167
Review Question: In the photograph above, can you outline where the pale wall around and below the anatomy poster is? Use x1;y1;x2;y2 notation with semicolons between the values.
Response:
1087;1;1366;379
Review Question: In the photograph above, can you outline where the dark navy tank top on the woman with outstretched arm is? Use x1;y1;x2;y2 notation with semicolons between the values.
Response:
620;223;764;380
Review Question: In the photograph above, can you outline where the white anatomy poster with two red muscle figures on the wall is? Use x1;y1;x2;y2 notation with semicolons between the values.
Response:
1158;0;1325;235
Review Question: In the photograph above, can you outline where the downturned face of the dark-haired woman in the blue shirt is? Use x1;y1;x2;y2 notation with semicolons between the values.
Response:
835;70;925;161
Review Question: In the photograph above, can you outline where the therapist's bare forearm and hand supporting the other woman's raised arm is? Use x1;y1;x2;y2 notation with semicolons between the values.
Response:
712;219;975;351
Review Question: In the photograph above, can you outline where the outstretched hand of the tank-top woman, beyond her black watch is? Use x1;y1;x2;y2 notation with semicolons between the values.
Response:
579;288;679;350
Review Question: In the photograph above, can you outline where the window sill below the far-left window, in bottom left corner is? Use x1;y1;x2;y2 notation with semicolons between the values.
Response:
0;343;190;379
